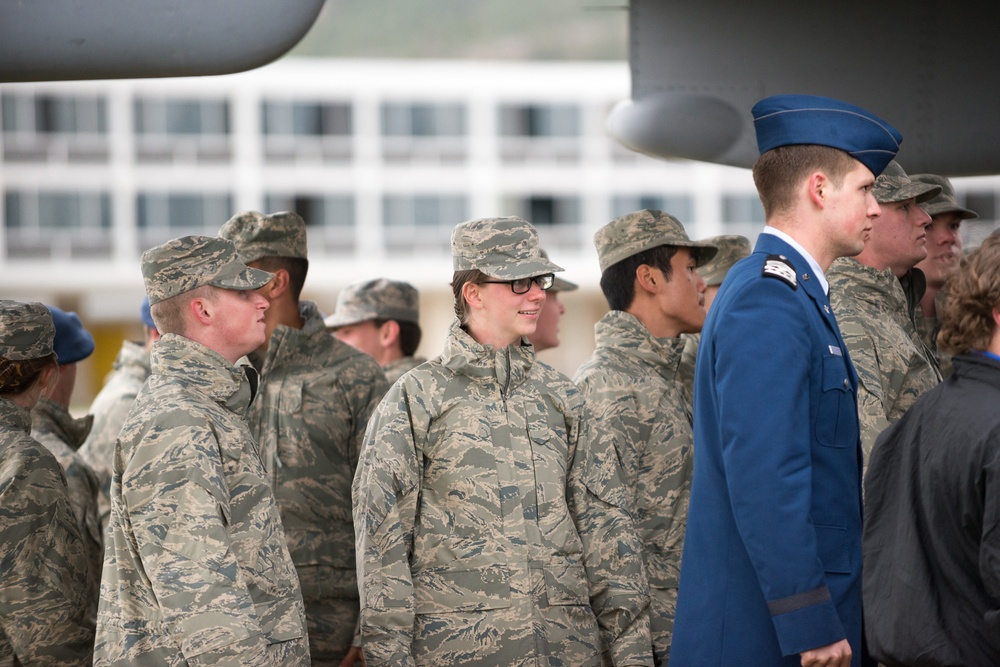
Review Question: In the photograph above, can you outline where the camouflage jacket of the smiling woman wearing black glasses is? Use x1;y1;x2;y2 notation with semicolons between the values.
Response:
353;320;652;667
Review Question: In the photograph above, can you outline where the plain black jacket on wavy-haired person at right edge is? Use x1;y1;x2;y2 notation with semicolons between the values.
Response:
864;354;1000;667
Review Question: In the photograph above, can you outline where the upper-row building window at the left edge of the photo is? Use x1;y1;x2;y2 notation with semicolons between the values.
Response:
0;92;109;162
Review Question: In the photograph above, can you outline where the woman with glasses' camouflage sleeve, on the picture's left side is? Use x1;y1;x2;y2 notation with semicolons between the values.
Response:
352;383;426;667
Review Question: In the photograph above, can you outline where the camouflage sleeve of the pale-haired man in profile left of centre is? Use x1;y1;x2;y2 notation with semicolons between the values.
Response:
122;410;270;666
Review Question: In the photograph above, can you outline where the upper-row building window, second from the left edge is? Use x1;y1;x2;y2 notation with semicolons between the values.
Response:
133;97;231;162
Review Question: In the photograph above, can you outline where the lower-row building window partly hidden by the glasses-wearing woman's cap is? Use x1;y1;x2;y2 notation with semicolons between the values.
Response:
382;194;469;256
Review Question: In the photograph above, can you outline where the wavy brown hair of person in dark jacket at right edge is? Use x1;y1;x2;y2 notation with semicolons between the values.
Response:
937;232;1000;354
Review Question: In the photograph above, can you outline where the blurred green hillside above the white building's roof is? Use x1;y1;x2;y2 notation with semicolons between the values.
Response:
290;0;628;60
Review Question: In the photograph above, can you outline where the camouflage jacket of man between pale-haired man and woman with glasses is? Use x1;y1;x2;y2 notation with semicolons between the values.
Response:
248;301;389;665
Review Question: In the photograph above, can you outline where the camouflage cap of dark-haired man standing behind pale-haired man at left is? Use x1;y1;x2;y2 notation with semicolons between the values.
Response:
219;211;307;264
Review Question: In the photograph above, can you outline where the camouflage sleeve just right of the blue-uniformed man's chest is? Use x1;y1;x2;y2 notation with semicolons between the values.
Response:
838;314;889;467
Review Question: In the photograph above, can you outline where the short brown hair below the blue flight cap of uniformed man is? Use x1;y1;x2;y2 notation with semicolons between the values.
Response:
753;144;860;218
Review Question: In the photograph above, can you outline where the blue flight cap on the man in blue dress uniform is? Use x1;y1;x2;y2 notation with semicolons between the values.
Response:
751;95;903;176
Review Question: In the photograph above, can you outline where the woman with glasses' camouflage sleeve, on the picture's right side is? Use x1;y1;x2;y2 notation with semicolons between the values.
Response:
567;400;653;667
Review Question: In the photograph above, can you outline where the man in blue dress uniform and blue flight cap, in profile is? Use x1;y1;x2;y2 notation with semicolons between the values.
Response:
670;95;901;667
